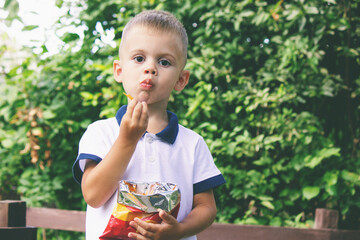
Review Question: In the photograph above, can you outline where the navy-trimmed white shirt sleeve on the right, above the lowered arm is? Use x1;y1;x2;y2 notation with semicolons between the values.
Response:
193;137;225;195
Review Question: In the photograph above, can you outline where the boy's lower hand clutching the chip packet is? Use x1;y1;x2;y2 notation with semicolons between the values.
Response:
128;210;181;240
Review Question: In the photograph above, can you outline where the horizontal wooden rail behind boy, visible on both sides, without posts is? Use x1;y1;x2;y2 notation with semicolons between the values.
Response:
27;205;360;240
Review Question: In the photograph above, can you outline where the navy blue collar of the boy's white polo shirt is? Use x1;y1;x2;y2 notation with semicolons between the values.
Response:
115;105;179;144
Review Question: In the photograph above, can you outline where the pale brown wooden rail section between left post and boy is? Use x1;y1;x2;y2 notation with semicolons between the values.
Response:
26;208;85;232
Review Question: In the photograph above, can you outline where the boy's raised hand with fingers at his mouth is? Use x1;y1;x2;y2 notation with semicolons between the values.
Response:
119;99;149;144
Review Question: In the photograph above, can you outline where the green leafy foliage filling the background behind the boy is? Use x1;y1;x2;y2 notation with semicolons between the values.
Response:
0;0;360;239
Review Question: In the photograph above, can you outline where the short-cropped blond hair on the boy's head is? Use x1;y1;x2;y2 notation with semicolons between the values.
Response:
120;10;188;62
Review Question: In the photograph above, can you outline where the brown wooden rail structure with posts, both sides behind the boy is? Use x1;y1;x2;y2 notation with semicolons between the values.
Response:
0;201;360;240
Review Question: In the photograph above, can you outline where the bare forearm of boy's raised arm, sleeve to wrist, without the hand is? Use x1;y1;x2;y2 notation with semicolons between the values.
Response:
81;138;136;207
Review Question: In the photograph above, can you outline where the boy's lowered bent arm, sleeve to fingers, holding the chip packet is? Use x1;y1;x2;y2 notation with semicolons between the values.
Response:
129;190;216;240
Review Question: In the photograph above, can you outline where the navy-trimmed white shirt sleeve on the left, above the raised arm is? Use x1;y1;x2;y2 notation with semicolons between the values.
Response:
72;122;107;184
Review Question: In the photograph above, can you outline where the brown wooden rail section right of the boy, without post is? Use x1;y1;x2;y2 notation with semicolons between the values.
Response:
198;223;360;240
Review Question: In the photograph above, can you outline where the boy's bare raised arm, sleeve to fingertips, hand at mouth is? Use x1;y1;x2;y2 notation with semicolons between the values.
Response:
81;100;148;207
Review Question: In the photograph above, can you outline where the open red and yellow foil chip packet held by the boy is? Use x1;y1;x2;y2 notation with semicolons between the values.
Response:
99;180;181;240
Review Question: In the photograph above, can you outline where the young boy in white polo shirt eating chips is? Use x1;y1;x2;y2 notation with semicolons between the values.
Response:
73;10;225;240
